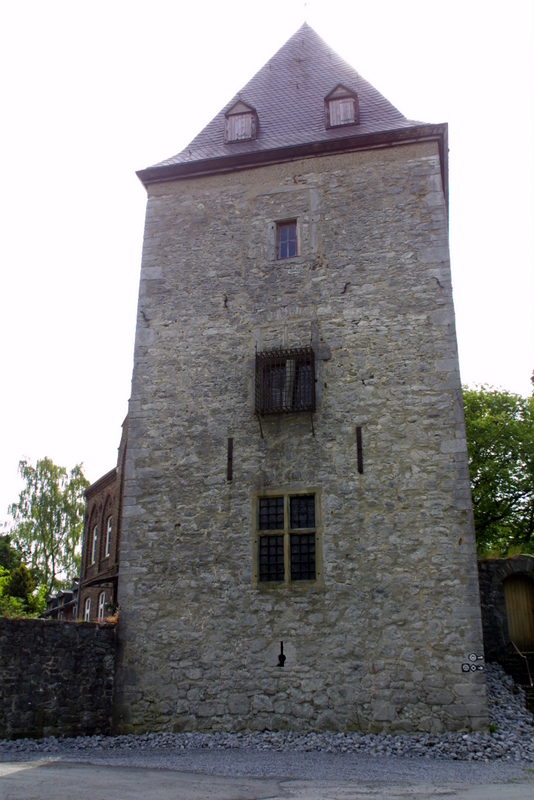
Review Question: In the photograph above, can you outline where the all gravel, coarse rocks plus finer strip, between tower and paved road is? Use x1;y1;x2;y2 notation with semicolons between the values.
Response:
0;664;534;780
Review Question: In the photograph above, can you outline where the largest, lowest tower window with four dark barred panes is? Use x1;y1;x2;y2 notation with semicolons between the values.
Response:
255;492;319;583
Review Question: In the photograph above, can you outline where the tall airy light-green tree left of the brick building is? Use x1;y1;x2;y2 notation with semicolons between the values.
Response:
9;458;89;594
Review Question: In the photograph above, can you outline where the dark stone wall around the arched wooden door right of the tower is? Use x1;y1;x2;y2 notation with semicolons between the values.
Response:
478;555;534;661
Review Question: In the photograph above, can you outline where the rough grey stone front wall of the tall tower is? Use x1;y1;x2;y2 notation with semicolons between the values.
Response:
114;144;487;732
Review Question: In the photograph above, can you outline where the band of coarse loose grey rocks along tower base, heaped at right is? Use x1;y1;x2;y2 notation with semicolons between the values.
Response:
0;664;534;763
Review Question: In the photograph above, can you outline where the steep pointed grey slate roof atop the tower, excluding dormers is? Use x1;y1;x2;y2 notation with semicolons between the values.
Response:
151;23;420;168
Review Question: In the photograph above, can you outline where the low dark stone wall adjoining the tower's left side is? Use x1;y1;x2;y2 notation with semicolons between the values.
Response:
0;618;115;739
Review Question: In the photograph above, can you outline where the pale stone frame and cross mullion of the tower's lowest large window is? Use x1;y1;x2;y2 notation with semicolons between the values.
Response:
250;486;324;591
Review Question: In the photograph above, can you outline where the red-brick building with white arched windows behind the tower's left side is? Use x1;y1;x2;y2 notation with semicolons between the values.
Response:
78;417;128;622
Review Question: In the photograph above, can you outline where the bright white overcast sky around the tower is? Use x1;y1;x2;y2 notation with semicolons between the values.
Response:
0;0;534;522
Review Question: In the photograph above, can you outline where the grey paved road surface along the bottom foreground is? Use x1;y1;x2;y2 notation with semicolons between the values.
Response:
0;754;534;800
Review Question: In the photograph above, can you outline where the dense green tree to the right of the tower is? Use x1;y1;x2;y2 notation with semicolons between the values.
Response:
464;387;534;556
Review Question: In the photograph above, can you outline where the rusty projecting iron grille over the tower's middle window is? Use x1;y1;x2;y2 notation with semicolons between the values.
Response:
256;347;315;417
